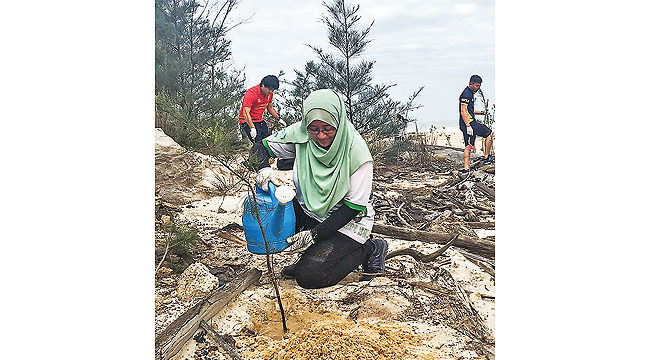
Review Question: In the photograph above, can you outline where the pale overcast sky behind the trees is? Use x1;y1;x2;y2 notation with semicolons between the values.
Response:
223;0;498;129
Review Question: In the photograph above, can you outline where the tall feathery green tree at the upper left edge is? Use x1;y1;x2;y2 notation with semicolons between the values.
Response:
155;0;244;149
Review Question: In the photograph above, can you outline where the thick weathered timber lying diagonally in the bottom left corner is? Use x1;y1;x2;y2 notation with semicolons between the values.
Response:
156;268;262;360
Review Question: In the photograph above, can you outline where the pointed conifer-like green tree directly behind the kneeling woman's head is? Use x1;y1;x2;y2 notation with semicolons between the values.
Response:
284;0;422;141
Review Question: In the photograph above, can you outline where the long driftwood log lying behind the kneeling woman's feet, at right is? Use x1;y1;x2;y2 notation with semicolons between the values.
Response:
372;223;494;259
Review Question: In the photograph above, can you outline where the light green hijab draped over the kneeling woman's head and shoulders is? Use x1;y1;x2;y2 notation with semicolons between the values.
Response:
266;89;372;217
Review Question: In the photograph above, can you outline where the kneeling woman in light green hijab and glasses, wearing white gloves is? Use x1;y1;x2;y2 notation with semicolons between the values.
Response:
251;89;387;289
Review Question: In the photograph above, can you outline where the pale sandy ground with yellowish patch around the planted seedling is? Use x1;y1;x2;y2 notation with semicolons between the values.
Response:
156;131;495;360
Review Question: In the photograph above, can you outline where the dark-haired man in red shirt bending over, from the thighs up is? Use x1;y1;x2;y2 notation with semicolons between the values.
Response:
239;75;286;143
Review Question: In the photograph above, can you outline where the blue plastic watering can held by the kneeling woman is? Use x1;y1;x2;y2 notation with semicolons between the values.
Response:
242;182;296;254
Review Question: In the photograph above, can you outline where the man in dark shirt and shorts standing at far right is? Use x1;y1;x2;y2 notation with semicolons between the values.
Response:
458;75;494;174
